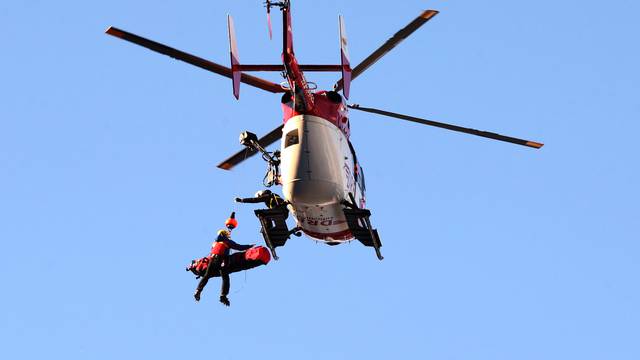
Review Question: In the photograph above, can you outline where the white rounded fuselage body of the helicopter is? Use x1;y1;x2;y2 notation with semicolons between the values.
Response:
280;115;365;244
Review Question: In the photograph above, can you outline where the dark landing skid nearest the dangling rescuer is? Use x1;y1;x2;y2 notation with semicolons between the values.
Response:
254;206;302;260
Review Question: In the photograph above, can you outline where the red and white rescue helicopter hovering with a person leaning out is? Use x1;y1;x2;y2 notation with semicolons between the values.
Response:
106;0;543;260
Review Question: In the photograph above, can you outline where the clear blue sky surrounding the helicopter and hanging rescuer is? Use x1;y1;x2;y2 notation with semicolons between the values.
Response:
0;0;640;360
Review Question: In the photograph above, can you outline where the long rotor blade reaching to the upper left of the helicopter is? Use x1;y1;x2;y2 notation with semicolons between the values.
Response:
105;26;285;93
